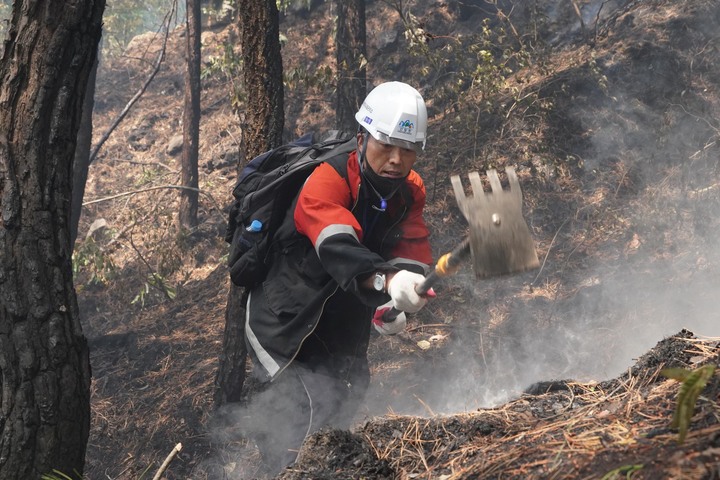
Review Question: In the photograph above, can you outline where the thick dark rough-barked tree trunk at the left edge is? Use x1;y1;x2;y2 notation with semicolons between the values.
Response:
0;0;105;480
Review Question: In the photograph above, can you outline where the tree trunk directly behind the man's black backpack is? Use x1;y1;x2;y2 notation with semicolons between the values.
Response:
215;0;285;405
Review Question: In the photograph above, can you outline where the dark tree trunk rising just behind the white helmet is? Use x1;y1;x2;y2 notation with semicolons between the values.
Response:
335;0;366;132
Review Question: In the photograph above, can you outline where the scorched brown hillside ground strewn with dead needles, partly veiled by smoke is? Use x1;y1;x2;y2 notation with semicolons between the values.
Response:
75;0;720;479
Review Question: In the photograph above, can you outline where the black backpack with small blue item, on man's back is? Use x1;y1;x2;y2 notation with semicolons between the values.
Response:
225;131;357;287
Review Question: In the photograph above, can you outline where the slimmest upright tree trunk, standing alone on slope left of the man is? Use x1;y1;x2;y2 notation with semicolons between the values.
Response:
178;0;201;228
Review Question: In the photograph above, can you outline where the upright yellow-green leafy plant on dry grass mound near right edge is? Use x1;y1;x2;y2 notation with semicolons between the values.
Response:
660;364;716;443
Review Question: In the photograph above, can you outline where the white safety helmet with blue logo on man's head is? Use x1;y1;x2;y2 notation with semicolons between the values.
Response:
355;82;427;153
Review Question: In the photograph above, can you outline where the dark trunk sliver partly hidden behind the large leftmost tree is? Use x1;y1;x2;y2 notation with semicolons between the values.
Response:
70;53;99;250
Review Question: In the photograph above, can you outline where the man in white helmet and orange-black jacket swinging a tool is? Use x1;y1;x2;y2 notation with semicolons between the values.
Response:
245;82;432;471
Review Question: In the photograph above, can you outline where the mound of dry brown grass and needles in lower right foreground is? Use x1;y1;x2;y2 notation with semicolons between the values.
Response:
336;337;720;480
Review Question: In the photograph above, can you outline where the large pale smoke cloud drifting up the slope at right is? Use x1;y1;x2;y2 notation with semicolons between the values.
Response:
367;0;720;415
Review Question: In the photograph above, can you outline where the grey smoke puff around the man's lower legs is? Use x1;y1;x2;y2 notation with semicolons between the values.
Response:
200;363;362;480
